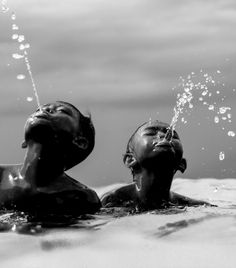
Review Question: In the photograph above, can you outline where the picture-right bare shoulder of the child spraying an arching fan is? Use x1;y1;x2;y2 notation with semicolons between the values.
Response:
170;191;214;207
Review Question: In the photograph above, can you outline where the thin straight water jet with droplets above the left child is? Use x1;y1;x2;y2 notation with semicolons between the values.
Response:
1;0;41;109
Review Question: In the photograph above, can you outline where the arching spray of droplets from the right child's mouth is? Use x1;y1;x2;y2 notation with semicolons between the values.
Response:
165;70;235;161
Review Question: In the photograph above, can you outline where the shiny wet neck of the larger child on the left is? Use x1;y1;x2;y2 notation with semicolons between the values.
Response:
20;141;63;187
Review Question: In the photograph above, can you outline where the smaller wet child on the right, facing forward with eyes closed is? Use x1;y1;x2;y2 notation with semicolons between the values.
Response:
101;121;209;210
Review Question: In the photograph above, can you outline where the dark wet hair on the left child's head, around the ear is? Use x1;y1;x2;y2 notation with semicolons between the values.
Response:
57;101;95;170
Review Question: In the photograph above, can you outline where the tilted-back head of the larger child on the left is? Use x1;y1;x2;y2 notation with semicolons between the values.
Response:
23;101;95;169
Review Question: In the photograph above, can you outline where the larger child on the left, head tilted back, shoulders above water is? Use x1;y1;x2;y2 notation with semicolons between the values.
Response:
0;101;100;216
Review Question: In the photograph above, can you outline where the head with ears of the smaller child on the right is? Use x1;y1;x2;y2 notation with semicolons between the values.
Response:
123;120;186;174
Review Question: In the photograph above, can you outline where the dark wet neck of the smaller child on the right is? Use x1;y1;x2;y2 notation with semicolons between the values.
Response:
134;168;174;208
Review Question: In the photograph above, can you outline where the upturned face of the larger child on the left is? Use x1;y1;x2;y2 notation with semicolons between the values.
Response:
25;102;79;142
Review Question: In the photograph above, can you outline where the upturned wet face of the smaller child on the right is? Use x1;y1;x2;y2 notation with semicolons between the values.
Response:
131;121;183;163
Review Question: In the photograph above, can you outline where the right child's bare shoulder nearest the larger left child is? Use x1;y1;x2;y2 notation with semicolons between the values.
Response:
101;184;135;207
